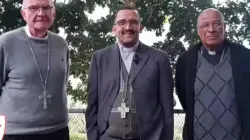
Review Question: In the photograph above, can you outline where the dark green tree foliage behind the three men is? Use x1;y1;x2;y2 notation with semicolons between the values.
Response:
0;0;250;102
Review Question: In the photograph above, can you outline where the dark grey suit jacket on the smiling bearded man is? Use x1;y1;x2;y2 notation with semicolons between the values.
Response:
86;43;173;140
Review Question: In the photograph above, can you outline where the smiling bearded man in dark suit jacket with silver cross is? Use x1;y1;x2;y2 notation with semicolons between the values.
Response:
86;7;173;140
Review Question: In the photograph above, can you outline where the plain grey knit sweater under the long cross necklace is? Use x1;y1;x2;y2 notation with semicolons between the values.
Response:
0;27;69;135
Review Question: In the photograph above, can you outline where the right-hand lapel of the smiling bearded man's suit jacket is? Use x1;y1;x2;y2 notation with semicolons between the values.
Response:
130;42;149;83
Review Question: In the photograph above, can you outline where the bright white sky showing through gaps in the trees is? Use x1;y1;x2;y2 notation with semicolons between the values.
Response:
57;0;250;109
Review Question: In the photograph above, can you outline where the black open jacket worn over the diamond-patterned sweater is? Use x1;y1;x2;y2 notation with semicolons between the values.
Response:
175;40;250;140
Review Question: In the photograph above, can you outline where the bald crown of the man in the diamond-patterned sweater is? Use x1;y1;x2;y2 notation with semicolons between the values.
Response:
197;8;225;27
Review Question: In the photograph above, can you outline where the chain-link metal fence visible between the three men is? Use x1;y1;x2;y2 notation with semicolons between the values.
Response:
69;109;185;140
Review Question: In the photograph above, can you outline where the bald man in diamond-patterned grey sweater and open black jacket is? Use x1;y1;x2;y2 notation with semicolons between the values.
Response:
175;9;250;140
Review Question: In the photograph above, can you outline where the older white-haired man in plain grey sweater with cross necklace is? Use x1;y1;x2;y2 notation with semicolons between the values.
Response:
0;0;69;140
